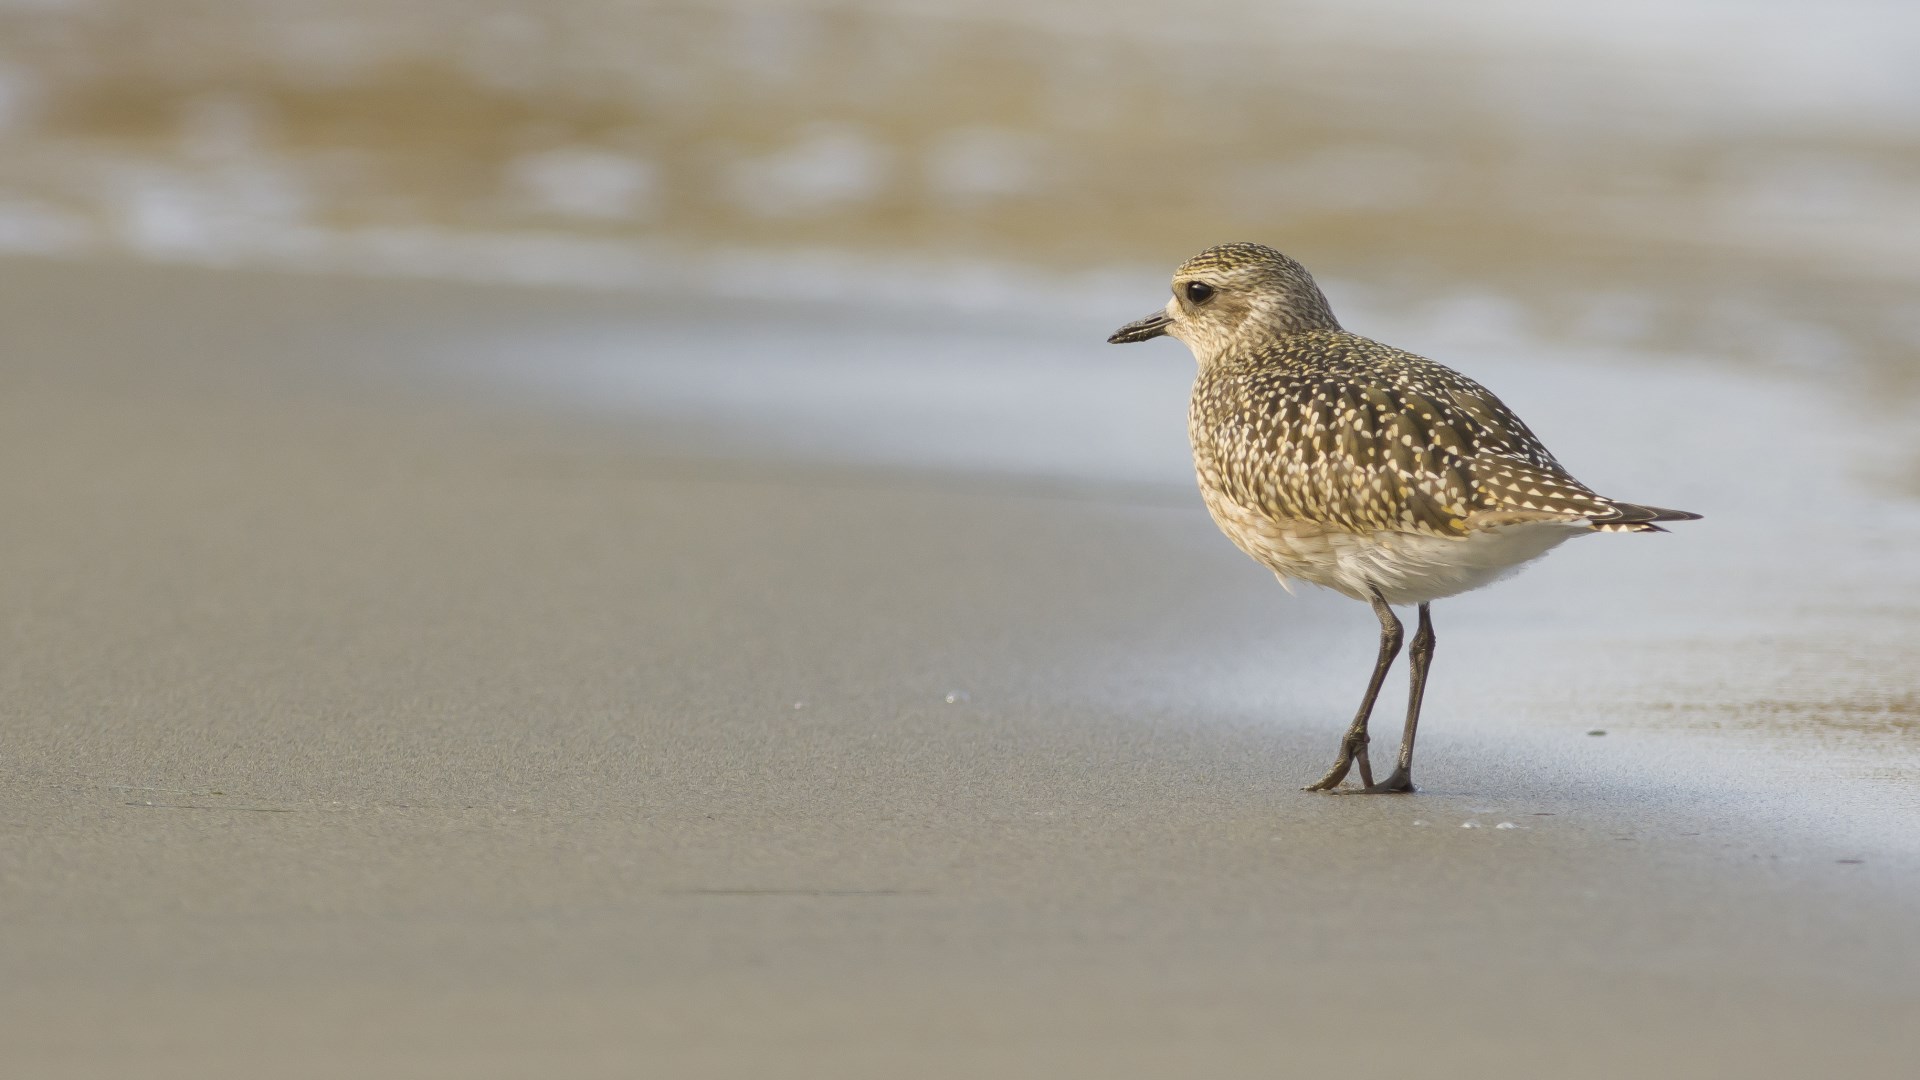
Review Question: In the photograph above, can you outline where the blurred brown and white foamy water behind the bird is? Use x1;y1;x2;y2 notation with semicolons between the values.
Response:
0;0;1920;388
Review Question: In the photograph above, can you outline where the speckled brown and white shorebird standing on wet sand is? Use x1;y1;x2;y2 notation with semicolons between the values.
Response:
1108;242;1699;794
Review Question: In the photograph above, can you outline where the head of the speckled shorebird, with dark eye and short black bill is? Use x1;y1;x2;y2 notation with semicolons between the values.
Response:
1106;244;1340;363
